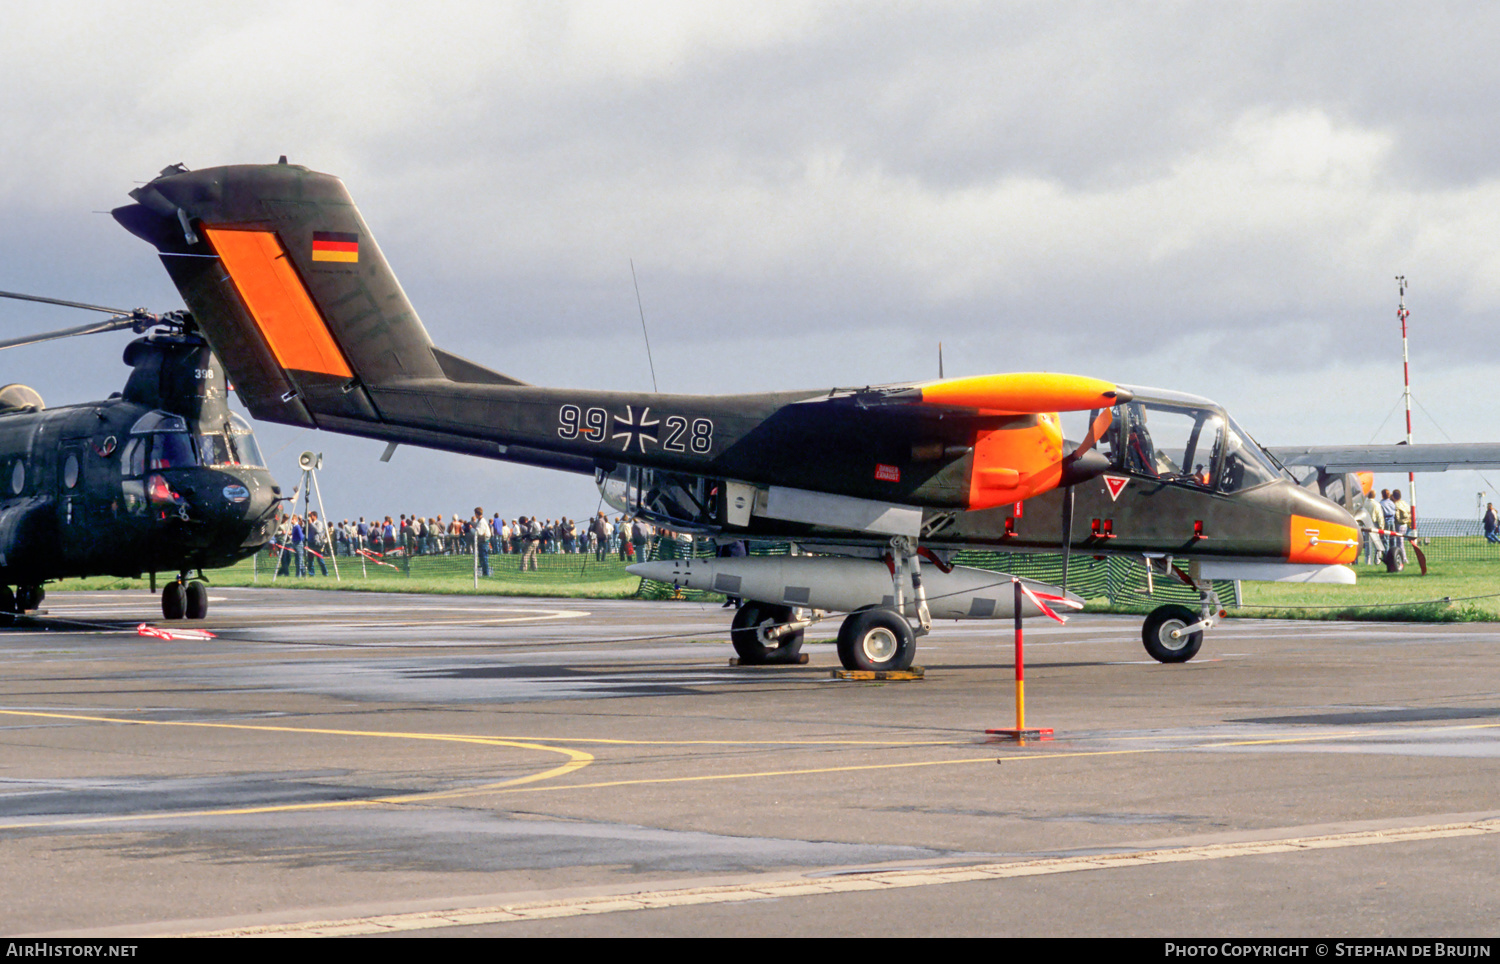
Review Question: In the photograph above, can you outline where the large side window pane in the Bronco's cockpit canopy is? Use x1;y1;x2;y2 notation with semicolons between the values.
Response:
1112;402;1224;489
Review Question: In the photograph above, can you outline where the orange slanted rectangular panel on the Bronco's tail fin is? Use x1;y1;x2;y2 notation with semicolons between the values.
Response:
204;226;354;378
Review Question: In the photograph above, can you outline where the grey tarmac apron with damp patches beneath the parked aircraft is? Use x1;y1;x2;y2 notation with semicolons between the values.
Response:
0;589;1500;939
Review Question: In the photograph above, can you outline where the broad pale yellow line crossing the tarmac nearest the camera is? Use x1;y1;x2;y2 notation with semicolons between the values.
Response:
177;820;1500;937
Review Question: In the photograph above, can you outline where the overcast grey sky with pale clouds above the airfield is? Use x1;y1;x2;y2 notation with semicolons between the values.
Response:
0;0;1500;517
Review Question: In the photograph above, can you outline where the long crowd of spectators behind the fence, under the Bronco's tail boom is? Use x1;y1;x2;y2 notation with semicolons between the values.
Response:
267;507;657;576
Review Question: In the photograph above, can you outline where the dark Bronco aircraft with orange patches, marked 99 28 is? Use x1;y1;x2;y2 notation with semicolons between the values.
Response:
114;157;1359;669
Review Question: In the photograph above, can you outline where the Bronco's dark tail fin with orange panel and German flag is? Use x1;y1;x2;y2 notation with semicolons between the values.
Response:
114;163;519;426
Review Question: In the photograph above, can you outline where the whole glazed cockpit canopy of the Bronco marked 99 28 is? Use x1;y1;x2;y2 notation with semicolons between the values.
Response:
1091;388;1290;493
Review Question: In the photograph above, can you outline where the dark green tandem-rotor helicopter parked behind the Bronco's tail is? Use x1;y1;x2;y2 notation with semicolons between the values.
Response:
0;291;281;619
